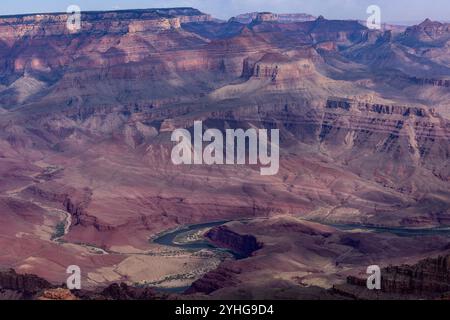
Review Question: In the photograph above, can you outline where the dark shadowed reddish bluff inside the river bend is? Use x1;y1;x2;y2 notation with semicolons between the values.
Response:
205;226;263;257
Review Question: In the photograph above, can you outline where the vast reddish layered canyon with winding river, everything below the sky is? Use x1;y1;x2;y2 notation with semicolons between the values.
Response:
0;8;450;300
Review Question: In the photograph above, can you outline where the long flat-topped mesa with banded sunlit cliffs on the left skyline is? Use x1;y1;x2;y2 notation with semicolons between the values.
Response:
0;8;211;40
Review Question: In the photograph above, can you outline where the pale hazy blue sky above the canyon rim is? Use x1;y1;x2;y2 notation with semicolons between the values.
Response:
0;0;450;22
